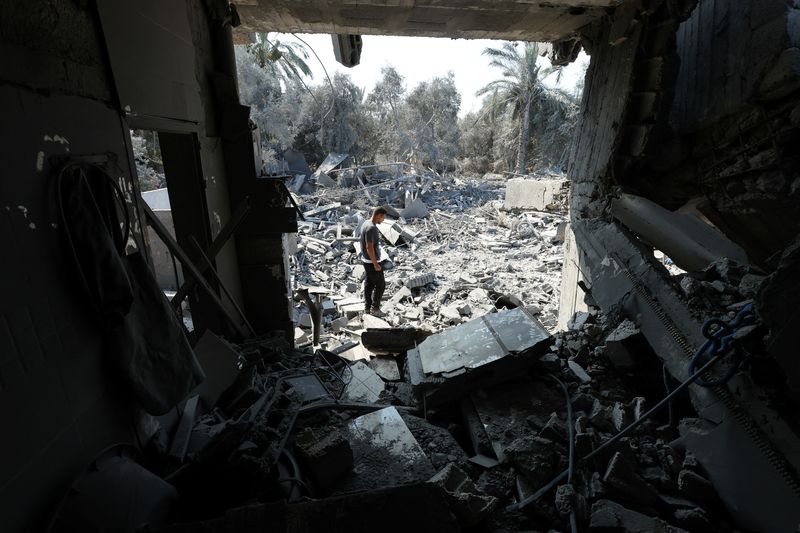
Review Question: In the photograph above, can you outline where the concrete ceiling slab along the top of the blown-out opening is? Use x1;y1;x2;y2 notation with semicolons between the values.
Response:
228;0;623;41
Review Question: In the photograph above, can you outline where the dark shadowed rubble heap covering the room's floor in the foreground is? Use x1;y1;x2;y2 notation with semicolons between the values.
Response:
106;300;744;532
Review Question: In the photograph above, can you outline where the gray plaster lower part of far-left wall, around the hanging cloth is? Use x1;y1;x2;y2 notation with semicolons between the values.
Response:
0;82;136;532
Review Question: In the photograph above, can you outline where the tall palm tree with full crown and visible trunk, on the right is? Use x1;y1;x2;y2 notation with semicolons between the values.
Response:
476;43;557;174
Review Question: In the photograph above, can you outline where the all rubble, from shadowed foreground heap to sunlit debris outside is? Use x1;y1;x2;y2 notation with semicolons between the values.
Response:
50;163;752;533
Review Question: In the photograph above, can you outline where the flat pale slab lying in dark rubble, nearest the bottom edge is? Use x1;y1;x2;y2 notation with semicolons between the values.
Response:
337;407;436;492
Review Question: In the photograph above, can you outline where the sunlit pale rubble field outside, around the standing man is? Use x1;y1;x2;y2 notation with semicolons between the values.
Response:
289;163;566;358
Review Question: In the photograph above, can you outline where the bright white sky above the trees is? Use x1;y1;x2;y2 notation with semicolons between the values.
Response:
277;34;589;116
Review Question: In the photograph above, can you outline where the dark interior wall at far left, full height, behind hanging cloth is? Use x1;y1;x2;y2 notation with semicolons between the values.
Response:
0;1;135;532
